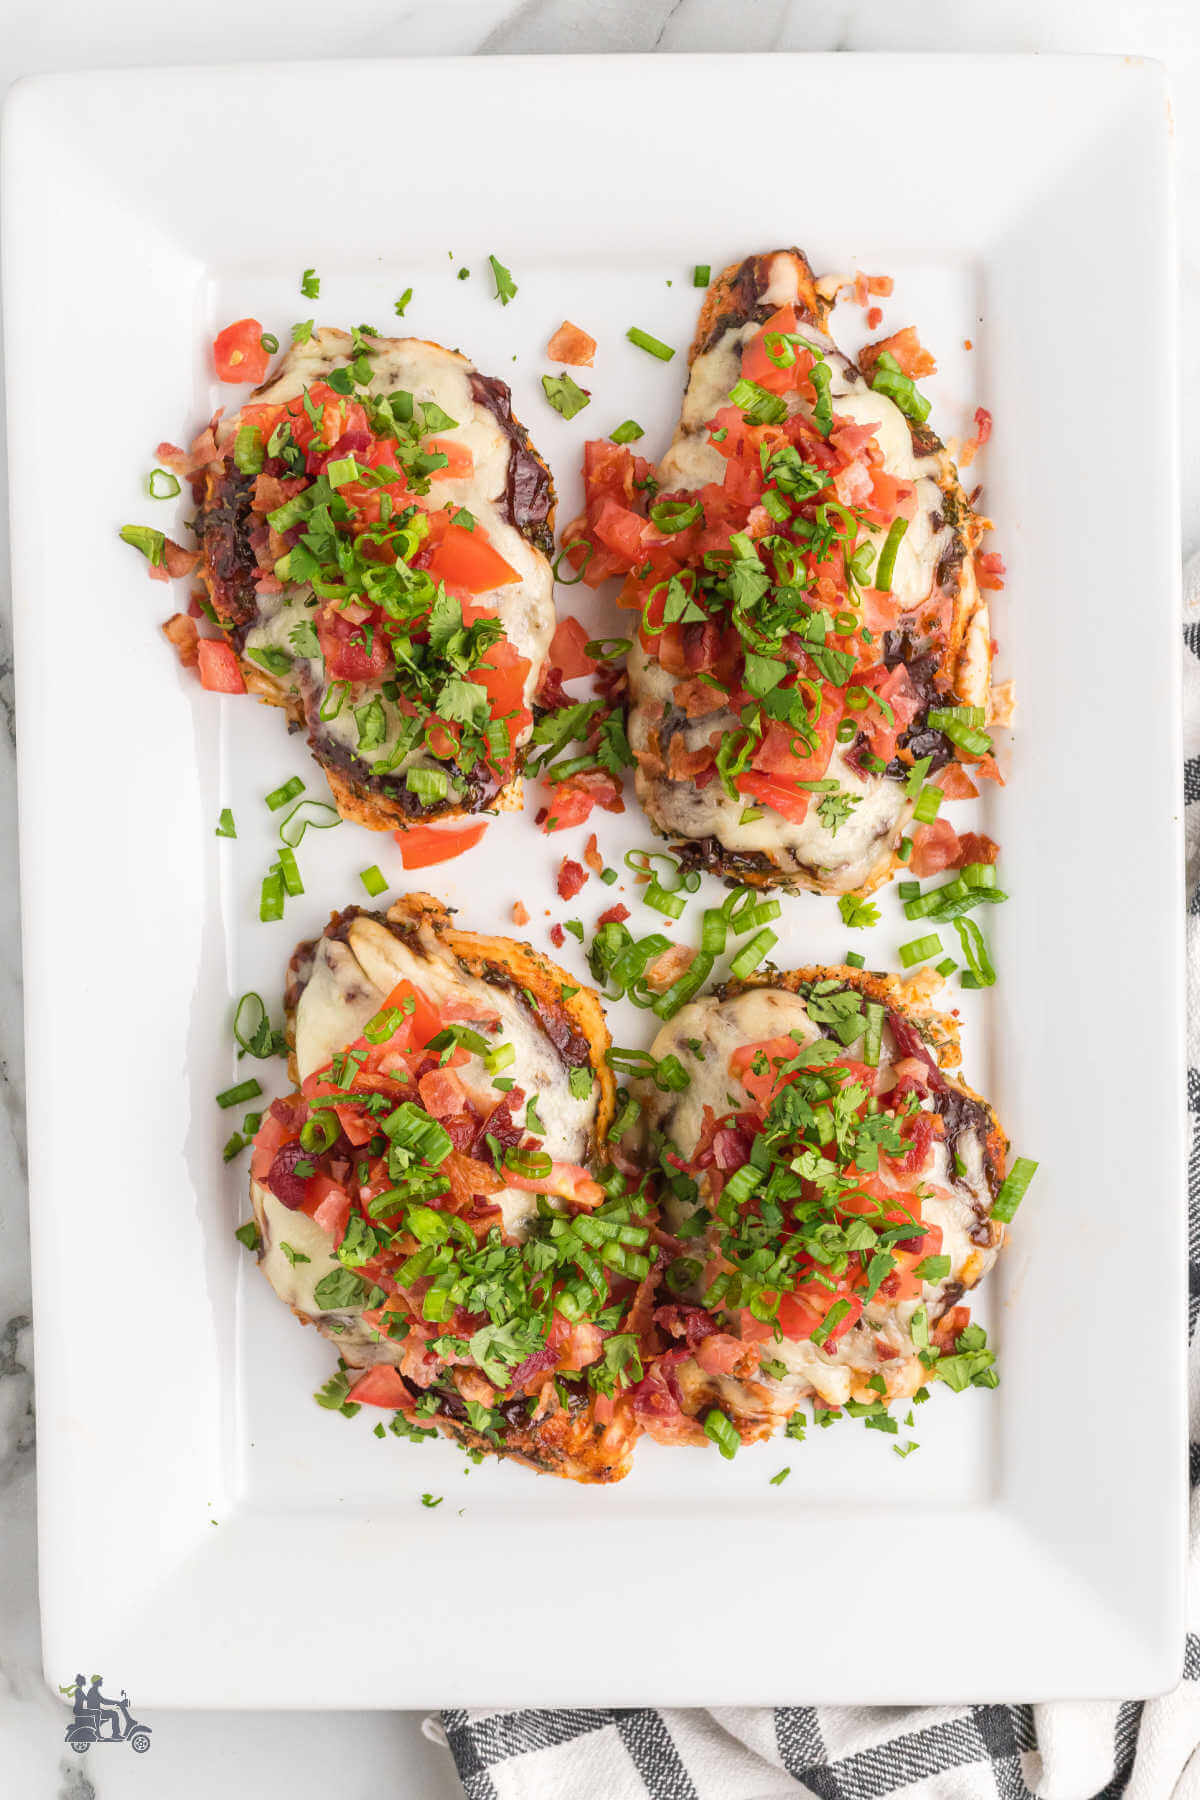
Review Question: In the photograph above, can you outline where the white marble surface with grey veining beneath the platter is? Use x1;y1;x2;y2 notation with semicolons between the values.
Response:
0;0;1200;1800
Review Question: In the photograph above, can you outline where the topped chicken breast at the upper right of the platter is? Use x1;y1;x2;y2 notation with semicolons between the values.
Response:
565;250;991;895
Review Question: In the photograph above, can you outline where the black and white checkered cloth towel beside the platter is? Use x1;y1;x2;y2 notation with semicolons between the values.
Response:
428;554;1200;1800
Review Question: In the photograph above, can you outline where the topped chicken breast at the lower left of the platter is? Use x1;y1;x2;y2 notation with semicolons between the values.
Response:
250;895;649;1481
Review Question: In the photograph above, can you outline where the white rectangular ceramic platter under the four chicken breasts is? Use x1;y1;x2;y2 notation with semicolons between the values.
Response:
4;56;1186;1706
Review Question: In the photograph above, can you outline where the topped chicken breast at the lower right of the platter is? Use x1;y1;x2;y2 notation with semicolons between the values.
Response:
637;968;1007;1442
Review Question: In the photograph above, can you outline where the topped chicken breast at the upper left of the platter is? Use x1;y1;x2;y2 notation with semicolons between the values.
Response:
187;328;554;830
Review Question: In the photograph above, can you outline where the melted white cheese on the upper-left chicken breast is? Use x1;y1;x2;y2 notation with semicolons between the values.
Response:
237;328;554;770
